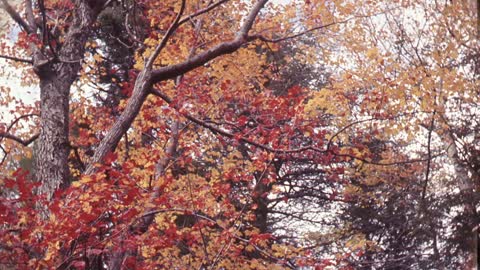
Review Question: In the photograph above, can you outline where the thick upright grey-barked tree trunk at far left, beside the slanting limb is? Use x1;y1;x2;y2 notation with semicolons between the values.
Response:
33;0;105;199
